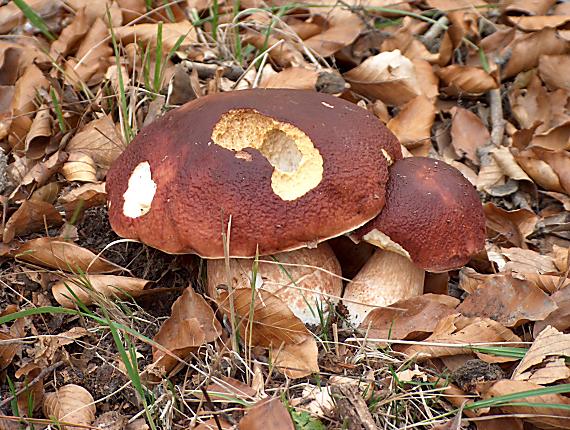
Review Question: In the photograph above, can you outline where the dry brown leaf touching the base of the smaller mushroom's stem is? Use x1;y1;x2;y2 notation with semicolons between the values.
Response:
360;294;459;339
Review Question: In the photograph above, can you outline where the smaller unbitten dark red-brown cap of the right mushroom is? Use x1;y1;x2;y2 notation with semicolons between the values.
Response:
353;157;485;272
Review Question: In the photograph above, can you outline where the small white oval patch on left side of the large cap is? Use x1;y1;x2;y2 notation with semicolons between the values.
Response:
123;161;156;218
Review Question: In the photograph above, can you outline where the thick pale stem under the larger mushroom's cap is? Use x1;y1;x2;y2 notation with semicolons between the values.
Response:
208;243;342;324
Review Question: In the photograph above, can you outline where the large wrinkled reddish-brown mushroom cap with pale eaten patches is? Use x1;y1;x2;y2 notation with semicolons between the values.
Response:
107;89;401;258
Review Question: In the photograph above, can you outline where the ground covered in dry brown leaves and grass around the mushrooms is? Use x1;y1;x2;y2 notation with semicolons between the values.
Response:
0;0;570;429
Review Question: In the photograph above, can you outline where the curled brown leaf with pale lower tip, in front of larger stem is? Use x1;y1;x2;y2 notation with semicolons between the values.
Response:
217;288;319;378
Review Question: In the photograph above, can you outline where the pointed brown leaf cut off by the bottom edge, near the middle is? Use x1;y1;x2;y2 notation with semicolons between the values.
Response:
239;397;295;430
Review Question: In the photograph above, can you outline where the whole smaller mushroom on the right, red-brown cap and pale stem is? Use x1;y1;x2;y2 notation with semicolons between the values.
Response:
343;157;485;324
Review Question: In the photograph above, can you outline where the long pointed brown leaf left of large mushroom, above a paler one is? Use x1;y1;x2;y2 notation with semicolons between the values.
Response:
10;237;122;274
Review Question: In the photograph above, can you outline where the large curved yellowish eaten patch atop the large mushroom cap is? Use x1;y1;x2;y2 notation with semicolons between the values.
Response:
212;109;323;201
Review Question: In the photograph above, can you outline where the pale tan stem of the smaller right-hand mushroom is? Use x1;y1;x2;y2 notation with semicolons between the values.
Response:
343;249;425;326
